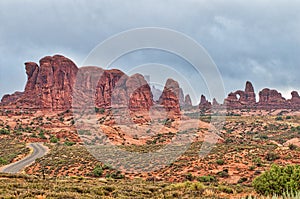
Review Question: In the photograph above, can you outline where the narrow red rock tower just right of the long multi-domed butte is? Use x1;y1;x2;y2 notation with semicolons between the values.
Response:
159;79;182;119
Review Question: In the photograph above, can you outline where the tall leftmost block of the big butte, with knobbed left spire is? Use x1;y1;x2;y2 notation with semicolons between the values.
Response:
1;55;78;110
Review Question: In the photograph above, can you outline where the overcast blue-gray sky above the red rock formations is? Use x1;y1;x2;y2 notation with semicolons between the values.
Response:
0;0;300;103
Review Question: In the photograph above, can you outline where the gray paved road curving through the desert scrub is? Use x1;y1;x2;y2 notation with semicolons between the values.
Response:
0;143;47;173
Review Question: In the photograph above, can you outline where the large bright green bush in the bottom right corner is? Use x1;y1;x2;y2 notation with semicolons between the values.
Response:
252;165;300;195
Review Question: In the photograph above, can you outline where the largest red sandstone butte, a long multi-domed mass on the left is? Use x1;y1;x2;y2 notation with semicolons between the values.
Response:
1;55;153;111
